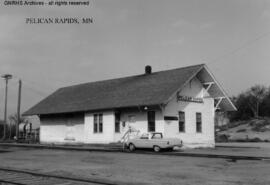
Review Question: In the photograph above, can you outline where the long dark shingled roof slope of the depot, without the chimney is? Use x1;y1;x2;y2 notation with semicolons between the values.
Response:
24;64;234;115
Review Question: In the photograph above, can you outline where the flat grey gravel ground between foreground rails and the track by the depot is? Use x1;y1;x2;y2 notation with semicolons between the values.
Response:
0;147;270;185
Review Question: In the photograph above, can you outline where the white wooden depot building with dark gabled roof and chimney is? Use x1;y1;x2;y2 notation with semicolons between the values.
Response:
24;64;236;147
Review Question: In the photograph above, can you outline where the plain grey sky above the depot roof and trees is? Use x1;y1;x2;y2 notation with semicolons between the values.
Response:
0;0;270;119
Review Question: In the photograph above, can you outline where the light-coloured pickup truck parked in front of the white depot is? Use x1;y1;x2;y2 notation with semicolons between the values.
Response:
126;132;183;152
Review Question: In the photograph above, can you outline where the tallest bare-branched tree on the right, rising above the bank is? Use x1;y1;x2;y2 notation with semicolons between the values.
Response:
247;85;267;117
